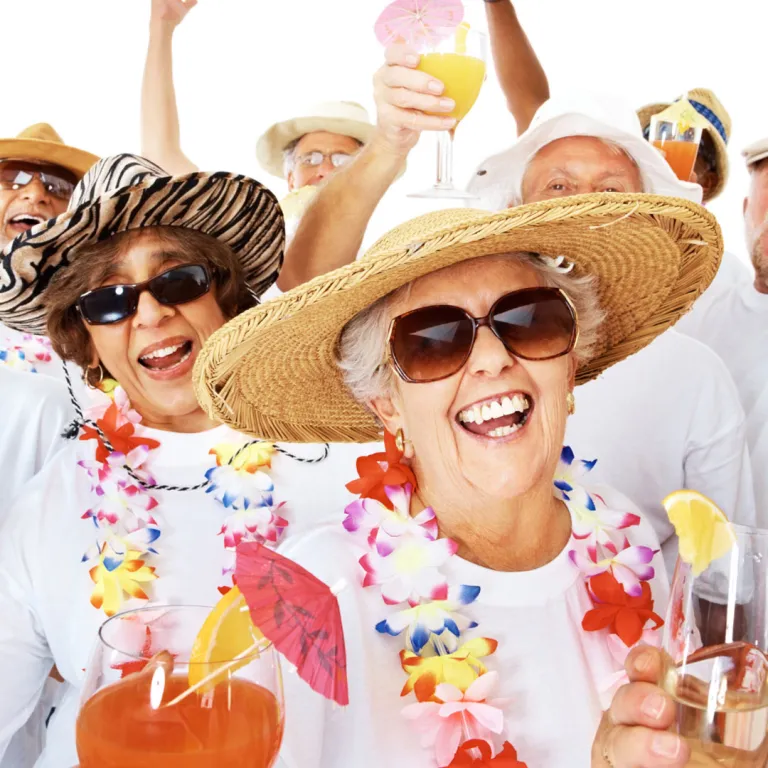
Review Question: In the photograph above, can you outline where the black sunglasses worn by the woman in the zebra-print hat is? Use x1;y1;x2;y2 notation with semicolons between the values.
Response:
77;264;211;325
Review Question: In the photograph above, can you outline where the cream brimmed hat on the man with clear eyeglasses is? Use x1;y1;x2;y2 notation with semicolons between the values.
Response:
256;101;376;179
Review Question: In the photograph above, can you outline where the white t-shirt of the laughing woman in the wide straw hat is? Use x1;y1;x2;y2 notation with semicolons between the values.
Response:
279;488;669;768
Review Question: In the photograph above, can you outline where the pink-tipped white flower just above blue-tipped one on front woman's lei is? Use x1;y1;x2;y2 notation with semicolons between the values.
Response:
360;534;458;606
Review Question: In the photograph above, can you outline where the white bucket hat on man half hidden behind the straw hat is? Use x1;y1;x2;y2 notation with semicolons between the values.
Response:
468;94;702;211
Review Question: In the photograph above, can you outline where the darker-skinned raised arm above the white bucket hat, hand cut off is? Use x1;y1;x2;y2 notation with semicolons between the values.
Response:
486;0;549;136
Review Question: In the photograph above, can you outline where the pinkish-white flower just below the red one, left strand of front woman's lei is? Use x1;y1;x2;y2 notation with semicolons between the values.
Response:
344;483;438;557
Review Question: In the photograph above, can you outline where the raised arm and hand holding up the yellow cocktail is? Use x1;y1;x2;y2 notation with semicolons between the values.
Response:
277;46;456;291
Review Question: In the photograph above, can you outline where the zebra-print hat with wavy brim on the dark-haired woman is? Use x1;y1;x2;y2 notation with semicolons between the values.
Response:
0;154;285;334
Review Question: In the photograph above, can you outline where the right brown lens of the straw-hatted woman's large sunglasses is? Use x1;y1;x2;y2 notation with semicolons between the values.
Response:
491;288;576;360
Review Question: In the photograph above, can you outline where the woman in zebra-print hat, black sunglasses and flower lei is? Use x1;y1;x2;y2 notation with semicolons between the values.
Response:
0;155;364;768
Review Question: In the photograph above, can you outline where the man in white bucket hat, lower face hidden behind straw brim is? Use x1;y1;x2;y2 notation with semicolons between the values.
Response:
469;95;756;565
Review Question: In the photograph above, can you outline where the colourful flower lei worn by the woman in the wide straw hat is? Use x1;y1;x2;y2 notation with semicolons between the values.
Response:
344;434;663;768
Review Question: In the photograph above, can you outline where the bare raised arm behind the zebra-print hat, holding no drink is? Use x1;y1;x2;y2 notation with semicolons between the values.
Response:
141;0;198;175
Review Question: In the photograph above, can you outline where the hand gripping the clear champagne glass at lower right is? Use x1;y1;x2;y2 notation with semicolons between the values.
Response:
592;647;690;768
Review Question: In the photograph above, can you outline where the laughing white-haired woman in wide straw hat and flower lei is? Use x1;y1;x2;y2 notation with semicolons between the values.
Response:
195;194;722;768
